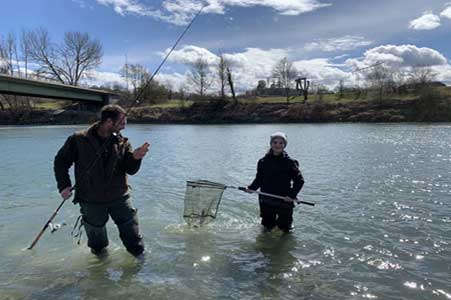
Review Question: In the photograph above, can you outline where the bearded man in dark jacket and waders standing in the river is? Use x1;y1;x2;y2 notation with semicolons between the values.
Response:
54;105;150;256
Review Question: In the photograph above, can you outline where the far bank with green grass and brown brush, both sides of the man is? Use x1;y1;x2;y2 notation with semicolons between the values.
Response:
0;87;451;124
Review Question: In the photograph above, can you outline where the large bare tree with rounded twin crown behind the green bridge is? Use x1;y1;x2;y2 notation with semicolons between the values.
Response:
27;28;102;86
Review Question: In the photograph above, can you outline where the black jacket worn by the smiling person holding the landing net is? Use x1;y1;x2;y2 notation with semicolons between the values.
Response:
249;151;304;204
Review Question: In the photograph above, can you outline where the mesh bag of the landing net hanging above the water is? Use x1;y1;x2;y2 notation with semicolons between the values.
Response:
183;180;226;226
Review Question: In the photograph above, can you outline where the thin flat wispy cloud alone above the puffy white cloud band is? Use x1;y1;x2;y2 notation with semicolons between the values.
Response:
304;35;373;52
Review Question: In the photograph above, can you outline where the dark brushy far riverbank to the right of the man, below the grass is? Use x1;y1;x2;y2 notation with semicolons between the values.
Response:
129;99;451;124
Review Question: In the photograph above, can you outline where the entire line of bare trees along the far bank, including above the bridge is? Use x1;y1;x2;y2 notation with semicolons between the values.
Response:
0;28;444;109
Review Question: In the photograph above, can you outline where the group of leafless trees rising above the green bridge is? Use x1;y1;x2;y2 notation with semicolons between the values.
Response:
0;28;103;86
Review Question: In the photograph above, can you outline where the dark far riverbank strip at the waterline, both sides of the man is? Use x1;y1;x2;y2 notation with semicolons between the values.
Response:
0;98;451;125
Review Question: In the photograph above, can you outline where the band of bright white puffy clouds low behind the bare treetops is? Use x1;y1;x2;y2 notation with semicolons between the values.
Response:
81;45;451;93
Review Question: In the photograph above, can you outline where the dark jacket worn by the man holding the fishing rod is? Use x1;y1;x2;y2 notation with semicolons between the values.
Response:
54;123;141;203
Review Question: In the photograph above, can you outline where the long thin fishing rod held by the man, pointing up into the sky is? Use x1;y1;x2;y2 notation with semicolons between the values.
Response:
27;4;205;250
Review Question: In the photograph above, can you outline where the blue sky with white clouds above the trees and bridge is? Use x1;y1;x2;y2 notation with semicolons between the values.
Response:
0;0;451;91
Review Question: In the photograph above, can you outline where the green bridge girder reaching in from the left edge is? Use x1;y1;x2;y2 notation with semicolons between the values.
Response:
0;74;111;106
